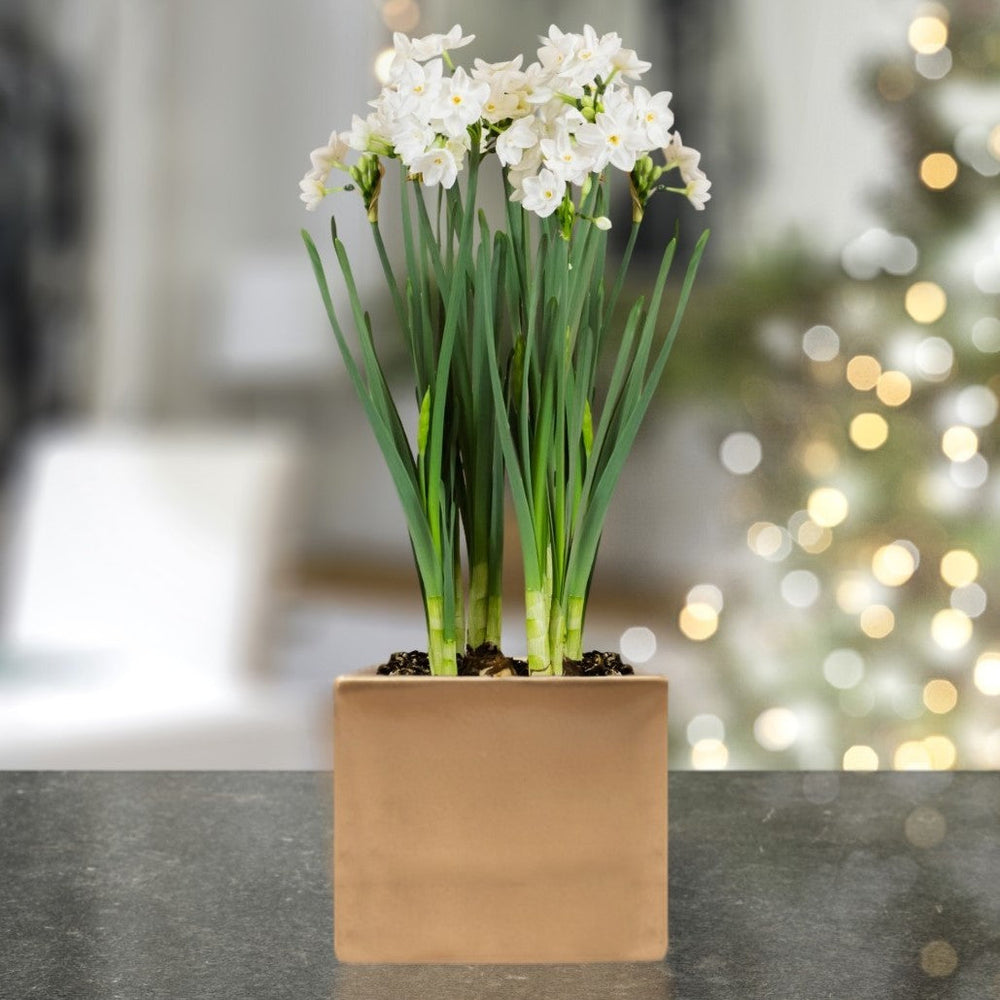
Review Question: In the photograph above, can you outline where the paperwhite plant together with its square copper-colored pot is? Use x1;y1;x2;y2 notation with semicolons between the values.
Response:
301;25;710;962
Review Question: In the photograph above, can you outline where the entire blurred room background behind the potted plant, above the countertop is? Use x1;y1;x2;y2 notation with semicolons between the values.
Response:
0;0;1000;768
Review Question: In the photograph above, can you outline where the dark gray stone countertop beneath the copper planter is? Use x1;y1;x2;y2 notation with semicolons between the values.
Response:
0;772;1000;1000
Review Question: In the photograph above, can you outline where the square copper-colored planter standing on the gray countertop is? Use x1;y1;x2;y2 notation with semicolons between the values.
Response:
333;673;667;963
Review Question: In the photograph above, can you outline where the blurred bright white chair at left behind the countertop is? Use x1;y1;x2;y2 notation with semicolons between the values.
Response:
0;427;324;768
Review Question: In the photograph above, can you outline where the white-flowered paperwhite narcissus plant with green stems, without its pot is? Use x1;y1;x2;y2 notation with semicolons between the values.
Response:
300;25;711;674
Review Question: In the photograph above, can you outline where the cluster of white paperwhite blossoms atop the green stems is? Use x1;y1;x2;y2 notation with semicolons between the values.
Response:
300;25;711;227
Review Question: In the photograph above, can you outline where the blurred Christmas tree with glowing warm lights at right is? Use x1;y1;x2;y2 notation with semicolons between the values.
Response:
674;0;1000;768
